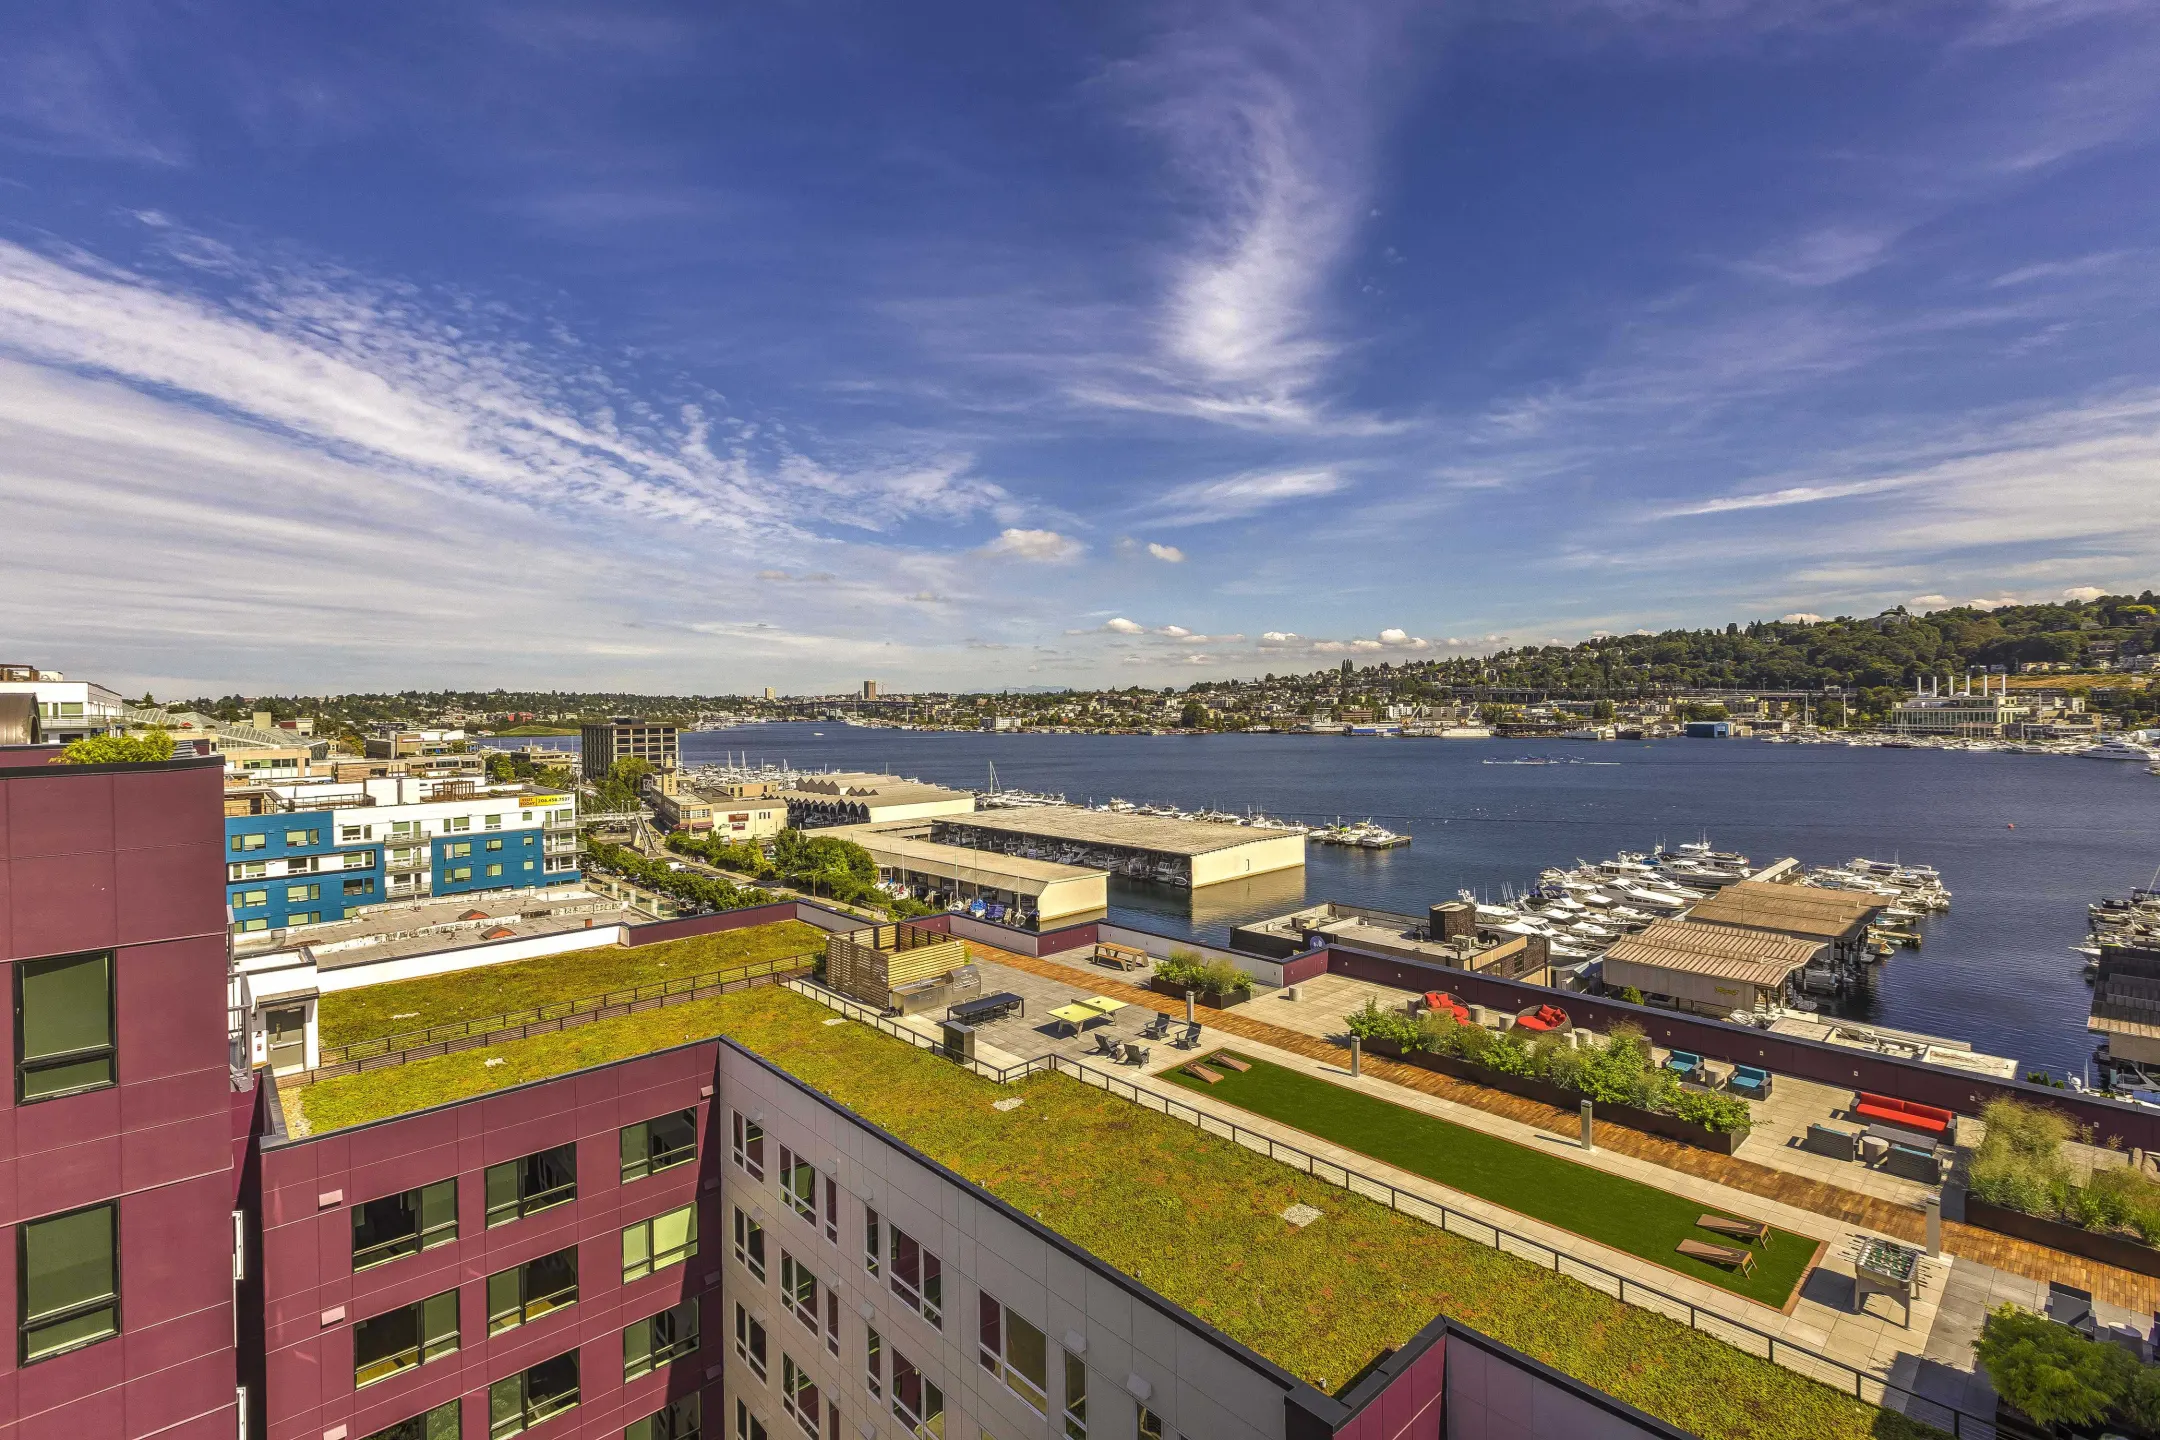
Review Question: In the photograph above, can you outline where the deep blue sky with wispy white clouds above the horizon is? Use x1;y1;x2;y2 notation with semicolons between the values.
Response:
0;0;2160;693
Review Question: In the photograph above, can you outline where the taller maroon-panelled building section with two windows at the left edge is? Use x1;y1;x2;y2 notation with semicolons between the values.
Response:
0;749;248;1440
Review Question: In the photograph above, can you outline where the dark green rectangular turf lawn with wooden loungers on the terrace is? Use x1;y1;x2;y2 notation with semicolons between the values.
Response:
1164;1051;1814;1308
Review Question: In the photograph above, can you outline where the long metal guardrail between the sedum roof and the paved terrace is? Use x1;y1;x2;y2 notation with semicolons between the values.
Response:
784;980;1996;1440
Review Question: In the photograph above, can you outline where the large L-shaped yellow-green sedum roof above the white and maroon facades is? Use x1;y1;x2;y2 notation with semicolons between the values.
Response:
300;984;1940;1440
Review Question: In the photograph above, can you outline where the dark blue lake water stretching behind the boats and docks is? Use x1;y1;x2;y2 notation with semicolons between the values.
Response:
544;723;2160;1073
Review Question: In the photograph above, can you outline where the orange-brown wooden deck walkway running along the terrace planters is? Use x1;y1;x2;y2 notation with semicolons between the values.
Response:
968;941;2160;1313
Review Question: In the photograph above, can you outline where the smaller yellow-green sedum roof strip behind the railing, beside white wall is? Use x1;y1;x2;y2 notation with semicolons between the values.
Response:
320;920;825;1045
